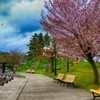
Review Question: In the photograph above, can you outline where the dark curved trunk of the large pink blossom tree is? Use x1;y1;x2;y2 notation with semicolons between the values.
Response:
88;57;98;83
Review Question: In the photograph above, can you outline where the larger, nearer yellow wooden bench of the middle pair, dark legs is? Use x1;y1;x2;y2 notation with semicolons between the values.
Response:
61;74;76;88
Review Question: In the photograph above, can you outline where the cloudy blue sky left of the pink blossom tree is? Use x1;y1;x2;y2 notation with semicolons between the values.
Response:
0;0;46;52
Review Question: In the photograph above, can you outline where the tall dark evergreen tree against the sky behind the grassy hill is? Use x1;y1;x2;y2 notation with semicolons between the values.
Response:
27;33;51;58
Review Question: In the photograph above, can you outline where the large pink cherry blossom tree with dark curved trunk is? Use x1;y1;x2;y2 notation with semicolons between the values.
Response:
40;0;100;83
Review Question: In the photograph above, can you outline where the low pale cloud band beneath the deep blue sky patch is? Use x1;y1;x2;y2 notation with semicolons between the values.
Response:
0;30;44;52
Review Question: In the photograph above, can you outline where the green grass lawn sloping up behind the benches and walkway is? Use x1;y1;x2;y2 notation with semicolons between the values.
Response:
16;58;100;91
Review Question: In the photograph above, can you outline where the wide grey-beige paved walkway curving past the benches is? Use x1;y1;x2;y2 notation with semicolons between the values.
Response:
0;74;97;100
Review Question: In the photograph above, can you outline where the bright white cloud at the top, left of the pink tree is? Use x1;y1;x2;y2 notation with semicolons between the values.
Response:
11;0;44;20
